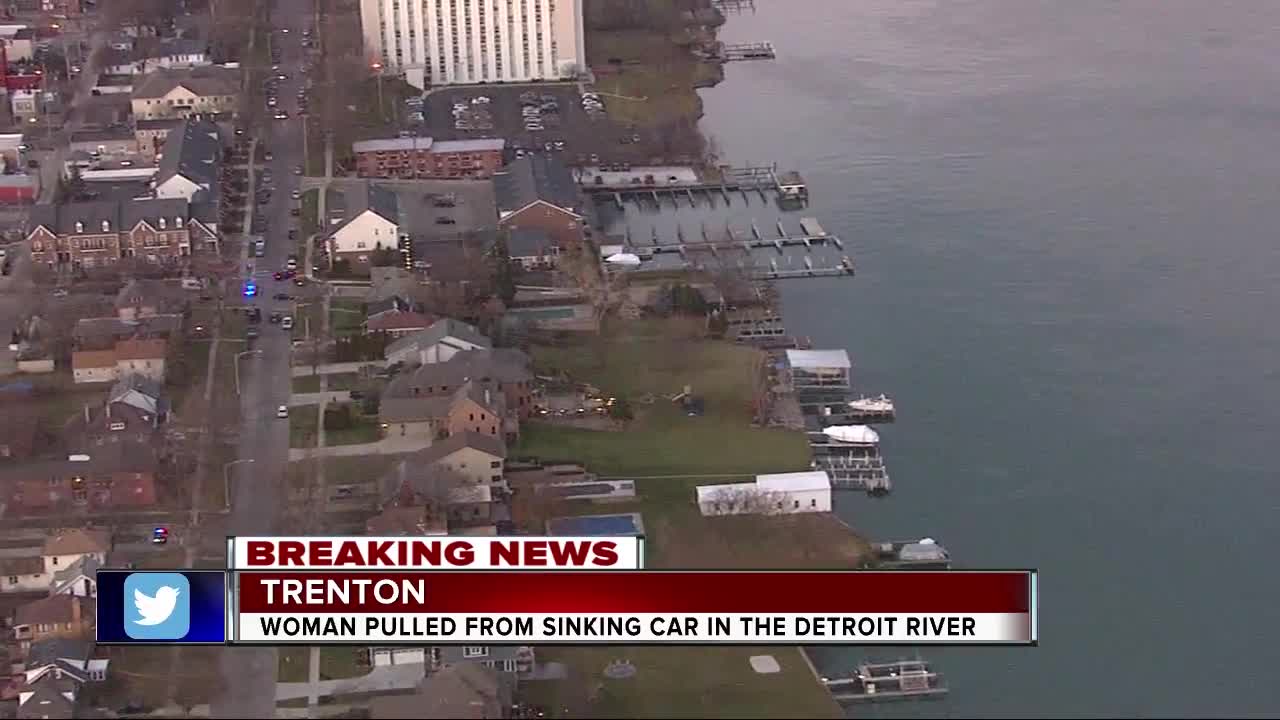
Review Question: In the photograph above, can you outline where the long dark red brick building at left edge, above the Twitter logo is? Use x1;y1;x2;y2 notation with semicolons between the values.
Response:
0;442;157;516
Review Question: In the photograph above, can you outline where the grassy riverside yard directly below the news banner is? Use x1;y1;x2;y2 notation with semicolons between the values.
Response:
521;647;841;717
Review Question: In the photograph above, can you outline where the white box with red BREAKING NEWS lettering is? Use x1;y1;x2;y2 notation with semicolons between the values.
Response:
227;536;644;570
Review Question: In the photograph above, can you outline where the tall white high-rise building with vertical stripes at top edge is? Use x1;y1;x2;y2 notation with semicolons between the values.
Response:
360;0;586;88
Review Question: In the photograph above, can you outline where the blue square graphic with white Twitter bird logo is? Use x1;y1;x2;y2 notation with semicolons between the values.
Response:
96;570;229;644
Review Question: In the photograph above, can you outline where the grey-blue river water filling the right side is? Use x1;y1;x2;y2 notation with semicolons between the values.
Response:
703;0;1280;716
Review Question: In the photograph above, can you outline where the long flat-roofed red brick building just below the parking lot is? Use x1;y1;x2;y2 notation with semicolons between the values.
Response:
352;137;507;179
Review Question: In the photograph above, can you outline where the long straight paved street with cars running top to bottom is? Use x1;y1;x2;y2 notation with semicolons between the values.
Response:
212;0;314;717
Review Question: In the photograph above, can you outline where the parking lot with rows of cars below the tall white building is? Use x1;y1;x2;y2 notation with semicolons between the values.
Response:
424;83;675;165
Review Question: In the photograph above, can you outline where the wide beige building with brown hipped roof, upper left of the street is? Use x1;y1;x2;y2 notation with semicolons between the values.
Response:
132;67;241;120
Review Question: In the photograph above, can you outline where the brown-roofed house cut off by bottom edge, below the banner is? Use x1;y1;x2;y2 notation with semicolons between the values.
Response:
369;662;513;720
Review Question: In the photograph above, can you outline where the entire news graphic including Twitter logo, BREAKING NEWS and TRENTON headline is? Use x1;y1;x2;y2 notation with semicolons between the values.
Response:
99;536;1037;646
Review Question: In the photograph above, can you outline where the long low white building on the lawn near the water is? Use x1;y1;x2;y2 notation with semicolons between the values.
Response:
695;470;831;515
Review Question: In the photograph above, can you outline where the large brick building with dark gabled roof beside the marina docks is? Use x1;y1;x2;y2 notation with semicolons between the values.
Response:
493;152;586;249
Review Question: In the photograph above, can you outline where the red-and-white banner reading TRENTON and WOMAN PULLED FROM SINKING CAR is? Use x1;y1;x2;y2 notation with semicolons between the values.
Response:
232;570;1037;646
